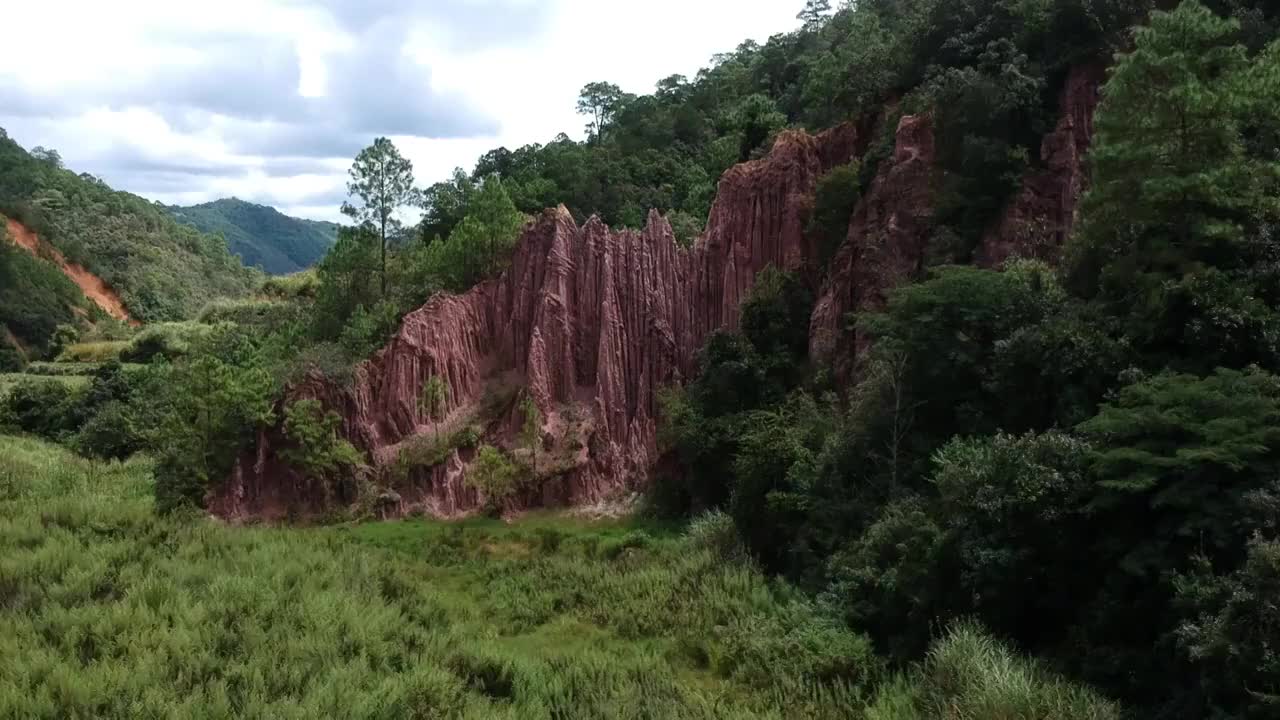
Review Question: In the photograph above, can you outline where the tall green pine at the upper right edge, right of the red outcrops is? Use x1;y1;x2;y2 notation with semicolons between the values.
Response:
1073;0;1280;358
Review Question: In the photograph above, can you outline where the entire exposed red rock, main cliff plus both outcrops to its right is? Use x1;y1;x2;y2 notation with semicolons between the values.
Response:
210;65;1103;518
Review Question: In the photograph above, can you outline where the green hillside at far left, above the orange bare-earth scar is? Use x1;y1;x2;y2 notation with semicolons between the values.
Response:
0;129;259;327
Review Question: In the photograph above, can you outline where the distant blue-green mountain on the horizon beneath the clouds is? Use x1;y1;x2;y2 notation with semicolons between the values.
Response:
169;197;338;275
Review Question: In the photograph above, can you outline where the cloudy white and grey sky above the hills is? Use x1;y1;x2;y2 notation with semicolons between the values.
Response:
0;0;804;220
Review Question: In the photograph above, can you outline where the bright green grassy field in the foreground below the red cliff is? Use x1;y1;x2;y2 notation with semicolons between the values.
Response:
0;436;1117;720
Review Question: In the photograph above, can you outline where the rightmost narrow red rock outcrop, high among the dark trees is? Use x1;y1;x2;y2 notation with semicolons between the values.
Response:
978;64;1105;266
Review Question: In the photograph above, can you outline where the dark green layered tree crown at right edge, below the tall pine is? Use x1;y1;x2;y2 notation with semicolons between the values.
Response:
1079;369;1280;577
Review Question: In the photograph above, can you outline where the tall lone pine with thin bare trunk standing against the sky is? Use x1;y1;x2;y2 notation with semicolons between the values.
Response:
342;137;421;297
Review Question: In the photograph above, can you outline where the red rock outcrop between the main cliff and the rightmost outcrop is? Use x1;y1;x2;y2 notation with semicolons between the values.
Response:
809;115;934;368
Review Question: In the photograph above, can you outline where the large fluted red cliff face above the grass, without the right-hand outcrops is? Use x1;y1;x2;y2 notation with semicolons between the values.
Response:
209;126;856;518
